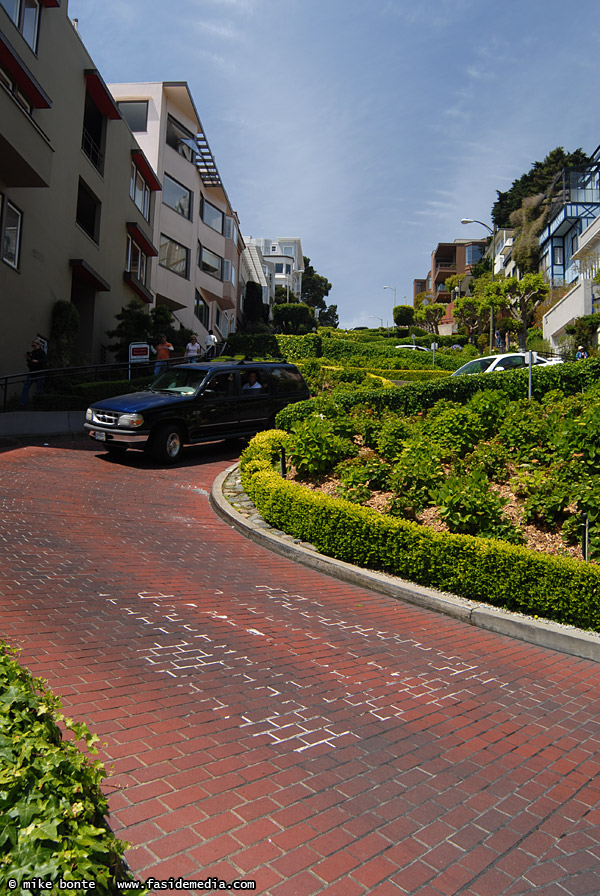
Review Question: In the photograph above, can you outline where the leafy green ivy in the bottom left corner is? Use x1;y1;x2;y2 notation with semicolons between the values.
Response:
0;642;141;894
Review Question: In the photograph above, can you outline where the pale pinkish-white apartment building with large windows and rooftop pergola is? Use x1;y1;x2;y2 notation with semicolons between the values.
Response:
109;81;244;344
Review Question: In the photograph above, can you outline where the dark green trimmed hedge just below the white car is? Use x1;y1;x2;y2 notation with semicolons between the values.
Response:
277;358;600;430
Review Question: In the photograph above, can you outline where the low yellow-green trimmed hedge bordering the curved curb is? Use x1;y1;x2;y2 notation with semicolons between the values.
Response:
240;430;600;631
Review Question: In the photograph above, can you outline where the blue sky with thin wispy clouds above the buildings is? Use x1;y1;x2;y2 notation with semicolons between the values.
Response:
68;0;600;328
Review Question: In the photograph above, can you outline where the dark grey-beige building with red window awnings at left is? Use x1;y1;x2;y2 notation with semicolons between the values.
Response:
0;0;161;374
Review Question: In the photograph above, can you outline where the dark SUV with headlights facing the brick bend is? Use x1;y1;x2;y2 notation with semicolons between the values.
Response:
85;361;310;463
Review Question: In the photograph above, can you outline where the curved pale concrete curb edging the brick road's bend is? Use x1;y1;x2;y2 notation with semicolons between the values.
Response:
210;464;600;662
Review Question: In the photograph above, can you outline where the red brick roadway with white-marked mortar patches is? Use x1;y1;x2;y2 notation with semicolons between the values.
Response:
0;440;600;896
